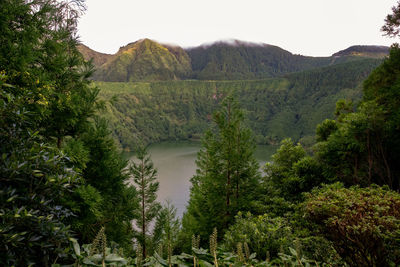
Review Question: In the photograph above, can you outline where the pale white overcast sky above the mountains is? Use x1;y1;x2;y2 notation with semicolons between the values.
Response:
78;0;398;56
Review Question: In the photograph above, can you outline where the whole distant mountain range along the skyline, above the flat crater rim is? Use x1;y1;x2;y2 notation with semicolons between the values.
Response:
79;39;389;82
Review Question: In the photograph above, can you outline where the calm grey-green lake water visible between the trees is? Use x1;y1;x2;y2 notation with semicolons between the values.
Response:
126;142;277;217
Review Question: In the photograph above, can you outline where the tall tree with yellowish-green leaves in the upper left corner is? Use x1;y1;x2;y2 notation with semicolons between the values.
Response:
0;0;98;148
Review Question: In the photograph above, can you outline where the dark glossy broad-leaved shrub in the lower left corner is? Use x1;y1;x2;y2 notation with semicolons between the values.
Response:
0;81;80;266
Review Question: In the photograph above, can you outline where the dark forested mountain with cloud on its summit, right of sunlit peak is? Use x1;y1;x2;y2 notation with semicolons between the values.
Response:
187;40;331;80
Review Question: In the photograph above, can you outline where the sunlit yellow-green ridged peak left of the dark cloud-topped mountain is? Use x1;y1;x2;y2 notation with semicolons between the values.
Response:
93;39;191;82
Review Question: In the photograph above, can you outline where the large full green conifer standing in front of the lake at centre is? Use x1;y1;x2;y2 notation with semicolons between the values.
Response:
183;96;260;243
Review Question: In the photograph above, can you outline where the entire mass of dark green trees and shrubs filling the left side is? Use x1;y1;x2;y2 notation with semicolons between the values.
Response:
0;0;139;266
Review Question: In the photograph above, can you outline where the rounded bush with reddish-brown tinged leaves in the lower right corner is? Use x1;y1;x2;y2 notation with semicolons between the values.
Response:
304;184;400;266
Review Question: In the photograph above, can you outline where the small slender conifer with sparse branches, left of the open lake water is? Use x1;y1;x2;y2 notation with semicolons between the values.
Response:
129;148;161;258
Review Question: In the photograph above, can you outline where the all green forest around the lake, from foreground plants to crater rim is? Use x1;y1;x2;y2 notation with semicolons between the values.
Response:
0;0;400;267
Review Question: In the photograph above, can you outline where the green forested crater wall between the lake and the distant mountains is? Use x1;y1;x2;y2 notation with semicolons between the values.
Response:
96;59;381;148
